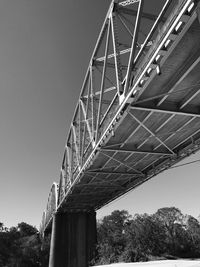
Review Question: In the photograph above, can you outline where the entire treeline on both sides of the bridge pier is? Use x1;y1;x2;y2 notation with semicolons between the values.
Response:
0;207;200;267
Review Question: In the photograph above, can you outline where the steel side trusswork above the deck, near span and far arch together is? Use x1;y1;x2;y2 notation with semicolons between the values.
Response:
39;0;196;234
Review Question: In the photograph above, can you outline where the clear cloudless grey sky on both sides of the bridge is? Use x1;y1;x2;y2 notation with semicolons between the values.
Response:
0;0;200;230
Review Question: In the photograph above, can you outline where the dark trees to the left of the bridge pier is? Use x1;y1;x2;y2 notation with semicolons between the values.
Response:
0;222;50;267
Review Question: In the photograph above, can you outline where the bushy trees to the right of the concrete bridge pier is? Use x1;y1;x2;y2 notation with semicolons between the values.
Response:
95;207;200;265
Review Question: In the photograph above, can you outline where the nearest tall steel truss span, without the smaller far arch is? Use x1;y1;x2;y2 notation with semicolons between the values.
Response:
58;0;177;194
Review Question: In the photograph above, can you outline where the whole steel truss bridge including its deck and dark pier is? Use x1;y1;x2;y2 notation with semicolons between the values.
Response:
40;0;200;267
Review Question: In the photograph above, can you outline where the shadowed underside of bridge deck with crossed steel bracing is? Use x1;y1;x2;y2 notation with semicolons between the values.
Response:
64;14;200;213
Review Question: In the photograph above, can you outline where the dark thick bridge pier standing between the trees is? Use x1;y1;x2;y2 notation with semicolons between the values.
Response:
49;211;97;267
